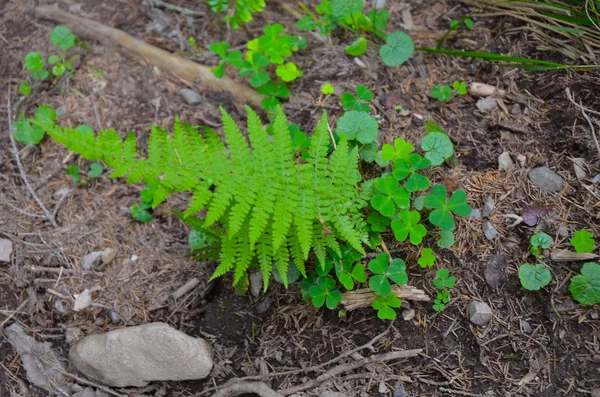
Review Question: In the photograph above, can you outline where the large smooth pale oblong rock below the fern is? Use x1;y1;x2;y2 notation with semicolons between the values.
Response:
69;323;213;387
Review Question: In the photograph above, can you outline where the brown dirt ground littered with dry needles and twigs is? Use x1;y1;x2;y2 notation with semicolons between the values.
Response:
0;0;600;397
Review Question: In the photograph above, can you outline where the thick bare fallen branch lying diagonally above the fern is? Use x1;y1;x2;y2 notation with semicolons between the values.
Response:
35;6;265;107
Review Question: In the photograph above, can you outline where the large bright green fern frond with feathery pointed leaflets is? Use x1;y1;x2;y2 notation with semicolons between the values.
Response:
36;108;372;290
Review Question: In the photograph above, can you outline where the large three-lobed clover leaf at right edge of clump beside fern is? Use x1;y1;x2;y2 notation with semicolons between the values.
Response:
425;185;471;230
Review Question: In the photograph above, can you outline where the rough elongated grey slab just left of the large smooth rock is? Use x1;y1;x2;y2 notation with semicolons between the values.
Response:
3;323;71;396
